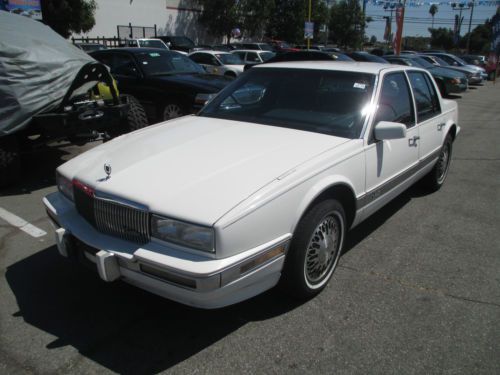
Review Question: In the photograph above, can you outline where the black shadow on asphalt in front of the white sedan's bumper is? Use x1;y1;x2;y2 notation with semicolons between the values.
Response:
6;246;300;374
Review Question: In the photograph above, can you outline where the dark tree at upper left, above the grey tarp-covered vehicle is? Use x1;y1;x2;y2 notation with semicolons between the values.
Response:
41;0;97;38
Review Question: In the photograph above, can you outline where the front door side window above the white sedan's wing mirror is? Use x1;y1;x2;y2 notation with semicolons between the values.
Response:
375;73;415;128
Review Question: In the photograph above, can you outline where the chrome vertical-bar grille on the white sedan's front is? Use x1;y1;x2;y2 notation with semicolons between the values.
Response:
94;197;151;243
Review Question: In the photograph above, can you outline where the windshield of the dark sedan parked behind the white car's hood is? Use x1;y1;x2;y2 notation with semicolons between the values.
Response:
135;50;205;76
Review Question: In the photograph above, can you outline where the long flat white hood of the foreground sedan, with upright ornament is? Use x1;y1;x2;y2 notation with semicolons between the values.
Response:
58;116;349;225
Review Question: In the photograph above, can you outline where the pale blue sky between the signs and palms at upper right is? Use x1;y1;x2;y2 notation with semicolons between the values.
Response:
365;0;496;41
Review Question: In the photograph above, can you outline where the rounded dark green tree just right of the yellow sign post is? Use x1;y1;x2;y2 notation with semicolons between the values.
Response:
330;0;367;48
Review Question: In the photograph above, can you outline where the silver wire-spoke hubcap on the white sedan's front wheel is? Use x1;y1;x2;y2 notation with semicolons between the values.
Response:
304;215;341;284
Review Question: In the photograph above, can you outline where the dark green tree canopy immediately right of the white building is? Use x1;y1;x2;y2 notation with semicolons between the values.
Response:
199;0;274;42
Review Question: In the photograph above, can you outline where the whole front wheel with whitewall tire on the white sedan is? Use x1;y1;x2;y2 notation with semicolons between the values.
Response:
280;199;346;299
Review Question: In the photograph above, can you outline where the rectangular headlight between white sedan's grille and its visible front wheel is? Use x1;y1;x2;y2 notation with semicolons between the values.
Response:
151;215;215;253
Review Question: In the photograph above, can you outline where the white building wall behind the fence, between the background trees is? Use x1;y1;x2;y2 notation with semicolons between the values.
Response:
73;0;219;44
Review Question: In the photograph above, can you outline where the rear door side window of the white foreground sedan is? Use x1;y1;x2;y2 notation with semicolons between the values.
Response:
408;72;441;122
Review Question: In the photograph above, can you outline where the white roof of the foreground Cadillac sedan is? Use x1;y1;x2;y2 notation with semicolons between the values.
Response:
252;61;414;74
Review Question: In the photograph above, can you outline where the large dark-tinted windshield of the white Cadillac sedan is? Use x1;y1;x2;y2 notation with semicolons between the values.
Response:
199;68;375;139
